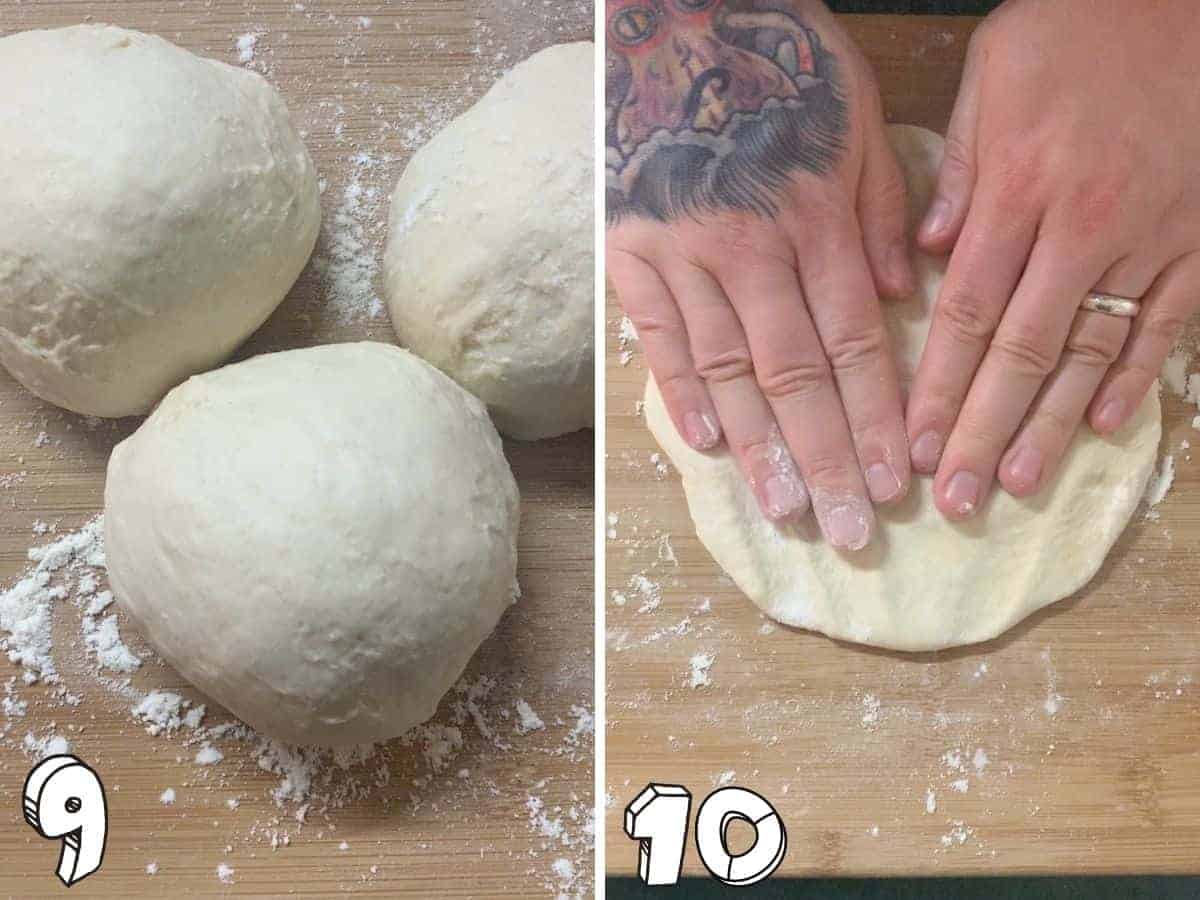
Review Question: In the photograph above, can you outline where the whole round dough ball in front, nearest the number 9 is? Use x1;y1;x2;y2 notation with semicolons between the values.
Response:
104;343;518;745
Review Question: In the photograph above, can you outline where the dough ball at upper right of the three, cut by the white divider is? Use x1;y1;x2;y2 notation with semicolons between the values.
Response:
384;43;595;440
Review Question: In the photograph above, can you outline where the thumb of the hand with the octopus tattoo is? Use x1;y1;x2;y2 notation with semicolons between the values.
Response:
858;107;916;300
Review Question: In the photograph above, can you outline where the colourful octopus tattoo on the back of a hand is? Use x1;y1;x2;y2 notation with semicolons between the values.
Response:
606;0;848;223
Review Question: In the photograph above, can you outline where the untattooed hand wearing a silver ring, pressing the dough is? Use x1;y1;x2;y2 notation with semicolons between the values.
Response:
908;0;1200;518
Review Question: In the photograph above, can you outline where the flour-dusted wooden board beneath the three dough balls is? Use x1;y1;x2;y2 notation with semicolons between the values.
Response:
0;0;593;898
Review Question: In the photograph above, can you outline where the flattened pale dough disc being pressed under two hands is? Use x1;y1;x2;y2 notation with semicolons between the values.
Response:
646;126;1162;650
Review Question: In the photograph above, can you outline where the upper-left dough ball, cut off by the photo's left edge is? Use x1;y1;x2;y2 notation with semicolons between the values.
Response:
0;25;320;416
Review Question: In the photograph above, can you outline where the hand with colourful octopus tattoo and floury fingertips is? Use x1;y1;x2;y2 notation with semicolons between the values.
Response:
606;0;913;550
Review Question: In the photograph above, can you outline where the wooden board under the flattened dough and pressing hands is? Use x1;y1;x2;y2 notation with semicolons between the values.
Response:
606;17;1200;876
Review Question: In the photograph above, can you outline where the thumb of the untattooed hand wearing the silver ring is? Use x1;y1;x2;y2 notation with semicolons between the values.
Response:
917;44;980;254
